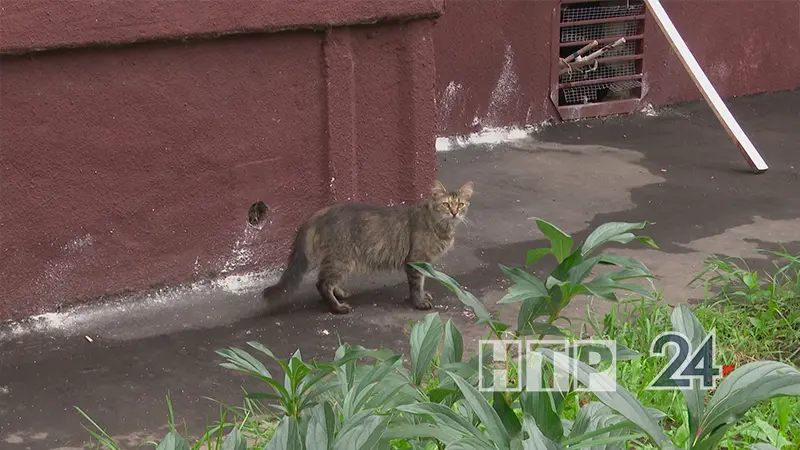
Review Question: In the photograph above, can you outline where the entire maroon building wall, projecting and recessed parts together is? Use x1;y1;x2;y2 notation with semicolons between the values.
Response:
0;0;800;320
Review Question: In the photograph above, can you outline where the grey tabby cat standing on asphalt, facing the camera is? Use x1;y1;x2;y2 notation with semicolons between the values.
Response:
263;181;472;314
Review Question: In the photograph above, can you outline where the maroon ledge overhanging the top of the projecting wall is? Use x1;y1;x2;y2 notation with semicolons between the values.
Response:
0;0;444;53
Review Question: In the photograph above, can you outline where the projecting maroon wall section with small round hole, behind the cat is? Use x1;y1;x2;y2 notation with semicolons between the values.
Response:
0;0;441;319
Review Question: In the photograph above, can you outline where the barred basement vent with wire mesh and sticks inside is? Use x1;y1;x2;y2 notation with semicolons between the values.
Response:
550;0;646;120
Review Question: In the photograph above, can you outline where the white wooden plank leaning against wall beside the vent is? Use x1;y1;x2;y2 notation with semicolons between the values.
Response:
644;0;769;173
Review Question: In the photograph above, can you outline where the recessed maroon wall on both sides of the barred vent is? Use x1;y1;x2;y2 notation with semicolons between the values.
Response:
434;0;800;136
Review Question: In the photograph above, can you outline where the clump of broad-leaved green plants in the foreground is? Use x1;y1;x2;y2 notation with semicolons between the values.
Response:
79;219;800;450
